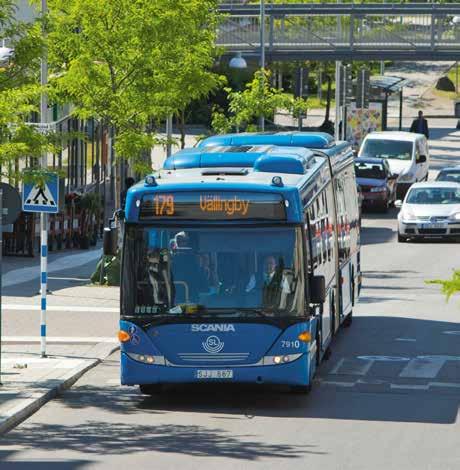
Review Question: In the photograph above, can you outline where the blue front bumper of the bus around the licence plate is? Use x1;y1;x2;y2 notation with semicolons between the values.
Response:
121;352;315;385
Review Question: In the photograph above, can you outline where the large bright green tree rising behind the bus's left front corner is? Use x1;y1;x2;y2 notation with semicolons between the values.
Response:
48;0;224;173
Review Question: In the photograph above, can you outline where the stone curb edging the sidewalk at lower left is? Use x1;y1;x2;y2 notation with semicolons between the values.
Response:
0;345;120;435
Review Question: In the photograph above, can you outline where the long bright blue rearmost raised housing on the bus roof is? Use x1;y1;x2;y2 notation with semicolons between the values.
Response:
197;132;334;149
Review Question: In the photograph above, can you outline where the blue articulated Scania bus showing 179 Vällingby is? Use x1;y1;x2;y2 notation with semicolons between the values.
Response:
109;135;360;394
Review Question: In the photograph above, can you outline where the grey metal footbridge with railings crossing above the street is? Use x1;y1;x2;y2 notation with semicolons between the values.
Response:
217;2;460;61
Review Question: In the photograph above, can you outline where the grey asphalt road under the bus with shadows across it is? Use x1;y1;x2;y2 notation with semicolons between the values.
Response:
0;132;460;470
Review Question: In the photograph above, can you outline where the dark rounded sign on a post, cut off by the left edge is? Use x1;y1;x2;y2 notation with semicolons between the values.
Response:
0;183;21;385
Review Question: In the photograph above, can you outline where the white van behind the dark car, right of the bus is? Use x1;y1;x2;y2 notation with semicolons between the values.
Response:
359;131;430;199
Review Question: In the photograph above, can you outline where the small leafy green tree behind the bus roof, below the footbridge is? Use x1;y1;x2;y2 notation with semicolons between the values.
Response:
212;70;307;134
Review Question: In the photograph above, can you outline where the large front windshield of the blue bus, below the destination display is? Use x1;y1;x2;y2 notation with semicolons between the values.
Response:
121;225;305;318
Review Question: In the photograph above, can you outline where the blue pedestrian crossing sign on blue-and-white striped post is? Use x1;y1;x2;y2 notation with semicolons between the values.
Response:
22;173;59;357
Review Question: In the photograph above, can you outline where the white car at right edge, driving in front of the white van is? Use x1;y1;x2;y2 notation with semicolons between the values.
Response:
395;181;460;242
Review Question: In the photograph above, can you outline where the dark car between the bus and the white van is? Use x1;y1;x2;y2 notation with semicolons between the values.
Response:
355;157;398;211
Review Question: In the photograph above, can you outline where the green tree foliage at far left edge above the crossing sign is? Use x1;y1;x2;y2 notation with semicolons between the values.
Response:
0;0;56;185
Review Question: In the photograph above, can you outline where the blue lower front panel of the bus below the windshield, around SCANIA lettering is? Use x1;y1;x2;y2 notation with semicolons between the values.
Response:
120;318;317;385
